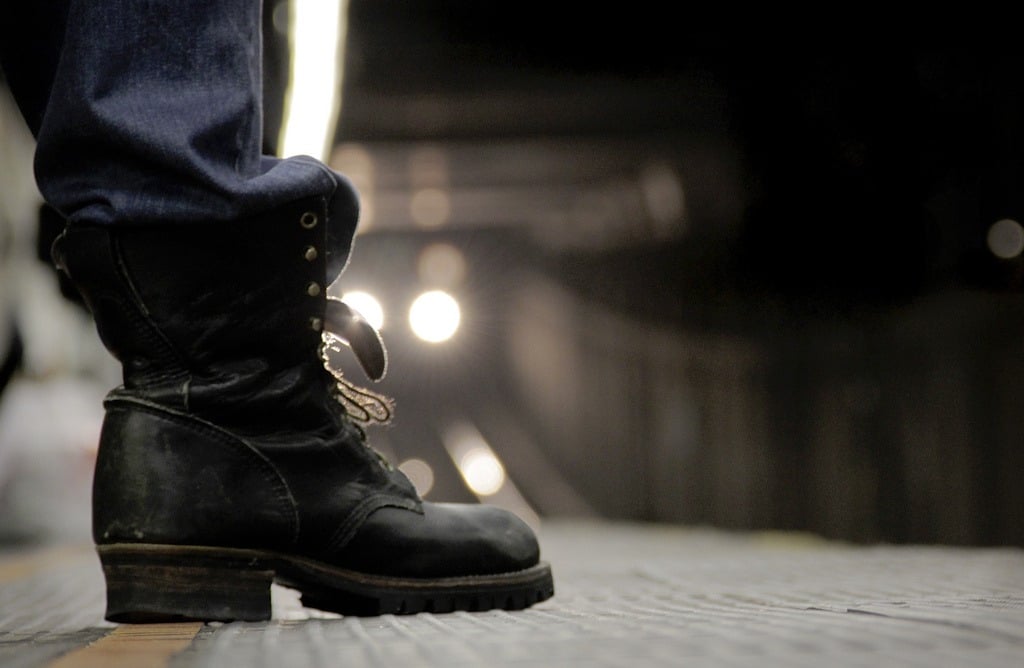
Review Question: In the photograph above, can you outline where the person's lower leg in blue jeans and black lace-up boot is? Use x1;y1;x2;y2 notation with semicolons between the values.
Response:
0;0;553;622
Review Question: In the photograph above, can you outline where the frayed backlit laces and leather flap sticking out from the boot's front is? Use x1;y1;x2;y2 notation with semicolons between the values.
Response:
321;297;393;425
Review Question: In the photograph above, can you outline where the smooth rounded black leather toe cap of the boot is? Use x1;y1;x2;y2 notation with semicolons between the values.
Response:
332;502;540;578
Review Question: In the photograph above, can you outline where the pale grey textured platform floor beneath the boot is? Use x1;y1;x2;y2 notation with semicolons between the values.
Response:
0;519;1024;668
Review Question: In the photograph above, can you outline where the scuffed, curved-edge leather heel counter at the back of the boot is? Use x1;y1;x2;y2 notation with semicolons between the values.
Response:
92;402;300;549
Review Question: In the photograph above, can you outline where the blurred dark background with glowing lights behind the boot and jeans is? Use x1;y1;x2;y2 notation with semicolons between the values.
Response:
0;0;1024;545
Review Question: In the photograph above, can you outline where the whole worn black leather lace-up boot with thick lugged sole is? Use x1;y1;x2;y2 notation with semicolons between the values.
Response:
53;192;554;622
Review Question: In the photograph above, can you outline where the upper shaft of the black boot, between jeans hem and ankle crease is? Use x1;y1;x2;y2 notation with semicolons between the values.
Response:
54;199;334;432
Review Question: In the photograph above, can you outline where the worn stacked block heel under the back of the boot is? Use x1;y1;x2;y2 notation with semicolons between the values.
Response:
96;544;273;624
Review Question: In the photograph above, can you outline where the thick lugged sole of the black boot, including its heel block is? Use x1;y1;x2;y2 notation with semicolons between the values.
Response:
96;543;555;624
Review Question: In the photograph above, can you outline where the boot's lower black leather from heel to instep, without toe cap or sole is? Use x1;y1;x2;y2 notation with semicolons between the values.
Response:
93;391;421;558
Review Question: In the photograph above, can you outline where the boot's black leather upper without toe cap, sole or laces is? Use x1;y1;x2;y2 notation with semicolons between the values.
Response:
54;200;420;554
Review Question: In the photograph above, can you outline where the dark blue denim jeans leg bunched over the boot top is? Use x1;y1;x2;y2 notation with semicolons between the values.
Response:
0;0;357;268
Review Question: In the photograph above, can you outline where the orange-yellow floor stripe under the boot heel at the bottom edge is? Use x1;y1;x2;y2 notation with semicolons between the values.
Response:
46;622;203;668
